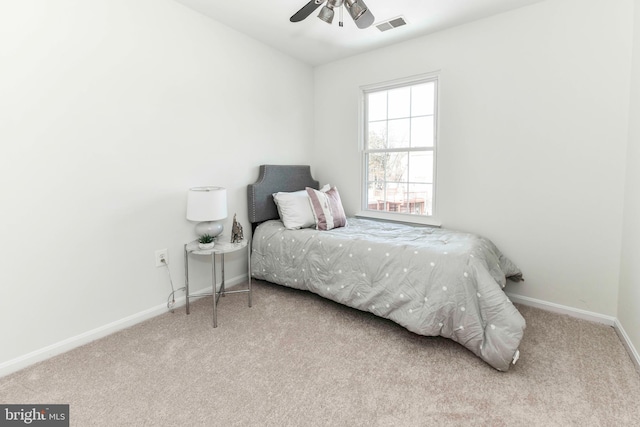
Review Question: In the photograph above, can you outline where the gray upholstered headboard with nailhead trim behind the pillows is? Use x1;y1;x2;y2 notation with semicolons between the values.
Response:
247;165;320;227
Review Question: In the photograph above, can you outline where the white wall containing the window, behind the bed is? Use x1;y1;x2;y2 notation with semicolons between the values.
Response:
314;0;633;316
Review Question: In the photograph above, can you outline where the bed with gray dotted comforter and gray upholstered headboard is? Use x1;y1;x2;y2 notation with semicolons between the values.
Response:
247;165;525;371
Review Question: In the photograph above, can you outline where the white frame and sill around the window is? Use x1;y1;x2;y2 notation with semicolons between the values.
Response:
356;70;441;226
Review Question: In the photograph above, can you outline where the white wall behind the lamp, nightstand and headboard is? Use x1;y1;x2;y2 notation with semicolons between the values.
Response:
0;0;313;367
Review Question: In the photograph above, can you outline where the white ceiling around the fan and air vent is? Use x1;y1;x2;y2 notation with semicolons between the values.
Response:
176;0;543;65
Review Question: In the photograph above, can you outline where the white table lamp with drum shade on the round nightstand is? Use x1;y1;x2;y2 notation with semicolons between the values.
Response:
187;187;227;237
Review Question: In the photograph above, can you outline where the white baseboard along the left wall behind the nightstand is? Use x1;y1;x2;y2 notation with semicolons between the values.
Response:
0;274;248;378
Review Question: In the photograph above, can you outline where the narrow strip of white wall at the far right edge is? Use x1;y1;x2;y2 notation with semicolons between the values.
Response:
618;0;640;358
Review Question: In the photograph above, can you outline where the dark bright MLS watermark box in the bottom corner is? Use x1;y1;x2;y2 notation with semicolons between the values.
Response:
0;405;69;427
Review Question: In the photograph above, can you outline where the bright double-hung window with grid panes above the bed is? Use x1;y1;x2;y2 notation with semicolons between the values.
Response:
362;75;438;216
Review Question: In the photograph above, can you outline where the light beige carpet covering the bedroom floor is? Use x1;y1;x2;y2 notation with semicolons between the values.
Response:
0;282;640;426
